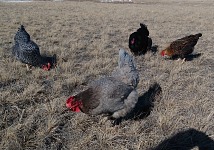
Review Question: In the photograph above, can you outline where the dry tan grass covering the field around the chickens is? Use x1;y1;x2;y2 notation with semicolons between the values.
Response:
0;0;214;150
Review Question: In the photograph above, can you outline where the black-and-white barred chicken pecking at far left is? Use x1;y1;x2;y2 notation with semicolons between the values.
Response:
12;25;56;70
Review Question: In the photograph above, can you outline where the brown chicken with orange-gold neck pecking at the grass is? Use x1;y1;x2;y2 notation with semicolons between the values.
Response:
161;33;202;61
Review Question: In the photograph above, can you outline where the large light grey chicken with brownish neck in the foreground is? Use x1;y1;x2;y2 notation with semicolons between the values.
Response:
66;49;139;125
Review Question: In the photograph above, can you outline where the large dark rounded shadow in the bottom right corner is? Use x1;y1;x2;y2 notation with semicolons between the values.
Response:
152;129;214;150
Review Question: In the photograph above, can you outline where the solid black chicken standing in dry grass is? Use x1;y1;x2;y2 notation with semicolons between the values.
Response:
129;23;152;56
